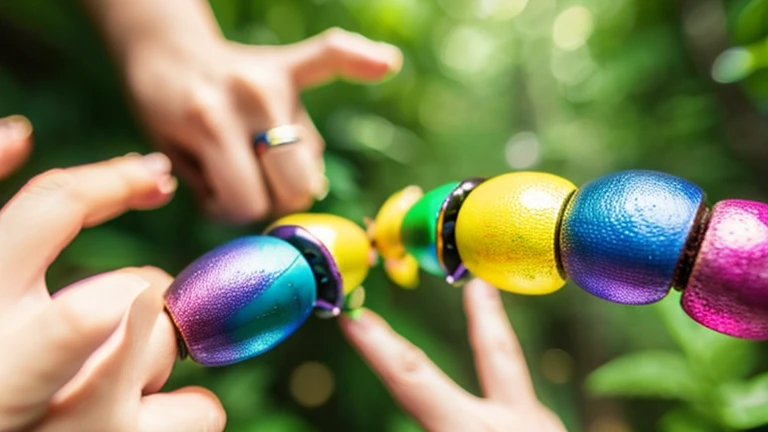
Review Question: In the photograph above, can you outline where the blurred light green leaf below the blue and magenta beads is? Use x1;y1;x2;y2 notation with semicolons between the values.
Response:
587;351;705;401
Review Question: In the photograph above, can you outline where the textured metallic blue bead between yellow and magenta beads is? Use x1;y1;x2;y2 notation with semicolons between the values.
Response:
560;170;704;305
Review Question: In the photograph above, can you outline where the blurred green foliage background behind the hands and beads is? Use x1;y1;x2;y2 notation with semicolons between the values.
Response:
0;0;768;432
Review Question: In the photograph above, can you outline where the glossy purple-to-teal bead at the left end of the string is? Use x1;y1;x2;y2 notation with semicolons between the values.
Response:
165;236;316;366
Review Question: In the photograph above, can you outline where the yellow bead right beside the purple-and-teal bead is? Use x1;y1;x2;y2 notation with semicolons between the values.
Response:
267;213;373;295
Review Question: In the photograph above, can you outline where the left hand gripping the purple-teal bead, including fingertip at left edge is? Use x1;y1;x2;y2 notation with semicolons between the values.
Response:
0;119;226;432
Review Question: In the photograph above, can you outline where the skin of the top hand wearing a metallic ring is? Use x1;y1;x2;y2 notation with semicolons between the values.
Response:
81;0;402;223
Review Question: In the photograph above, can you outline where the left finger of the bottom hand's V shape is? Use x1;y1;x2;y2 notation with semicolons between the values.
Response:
340;310;478;431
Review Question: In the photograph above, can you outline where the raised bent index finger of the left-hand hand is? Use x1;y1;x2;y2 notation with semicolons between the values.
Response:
0;153;175;303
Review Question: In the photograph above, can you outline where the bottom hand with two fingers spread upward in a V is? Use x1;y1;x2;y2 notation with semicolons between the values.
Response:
340;280;565;432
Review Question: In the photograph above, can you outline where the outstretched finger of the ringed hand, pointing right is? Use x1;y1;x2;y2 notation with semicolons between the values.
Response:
282;28;403;88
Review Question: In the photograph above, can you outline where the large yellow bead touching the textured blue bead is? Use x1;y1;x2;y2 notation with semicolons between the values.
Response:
456;172;576;295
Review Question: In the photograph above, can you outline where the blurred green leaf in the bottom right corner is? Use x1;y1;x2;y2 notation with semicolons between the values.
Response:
717;373;768;429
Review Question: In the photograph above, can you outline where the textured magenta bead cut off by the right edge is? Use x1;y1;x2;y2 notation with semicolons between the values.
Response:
682;200;768;340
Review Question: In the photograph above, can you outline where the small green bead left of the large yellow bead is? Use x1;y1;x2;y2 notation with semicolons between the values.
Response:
401;182;459;276
